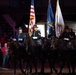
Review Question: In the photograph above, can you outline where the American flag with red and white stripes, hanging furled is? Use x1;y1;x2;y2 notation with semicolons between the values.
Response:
29;0;36;35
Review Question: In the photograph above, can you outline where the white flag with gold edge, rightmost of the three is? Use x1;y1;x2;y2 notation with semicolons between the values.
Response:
55;0;65;37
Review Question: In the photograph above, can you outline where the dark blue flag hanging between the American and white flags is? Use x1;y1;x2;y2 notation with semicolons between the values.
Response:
47;0;54;34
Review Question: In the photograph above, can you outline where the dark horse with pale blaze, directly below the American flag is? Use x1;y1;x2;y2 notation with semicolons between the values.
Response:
25;35;37;73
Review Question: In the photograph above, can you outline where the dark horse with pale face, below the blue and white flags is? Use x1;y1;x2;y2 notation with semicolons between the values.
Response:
47;37;58;73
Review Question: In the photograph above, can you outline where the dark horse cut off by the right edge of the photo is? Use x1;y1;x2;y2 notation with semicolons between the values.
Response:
69;39;76;73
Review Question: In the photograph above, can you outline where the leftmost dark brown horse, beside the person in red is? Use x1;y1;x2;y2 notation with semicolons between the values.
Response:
9;40;26;75
